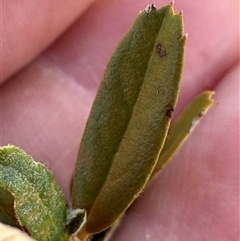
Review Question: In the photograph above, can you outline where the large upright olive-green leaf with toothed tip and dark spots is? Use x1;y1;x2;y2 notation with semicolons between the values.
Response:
72;2;186;233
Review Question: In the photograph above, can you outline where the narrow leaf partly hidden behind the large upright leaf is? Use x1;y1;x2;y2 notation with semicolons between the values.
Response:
152;91;214;176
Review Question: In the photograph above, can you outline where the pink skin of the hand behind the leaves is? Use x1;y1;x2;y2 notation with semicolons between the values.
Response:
0;0;239;241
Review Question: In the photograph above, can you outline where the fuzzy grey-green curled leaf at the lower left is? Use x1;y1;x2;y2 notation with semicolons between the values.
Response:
0;146;66;241
